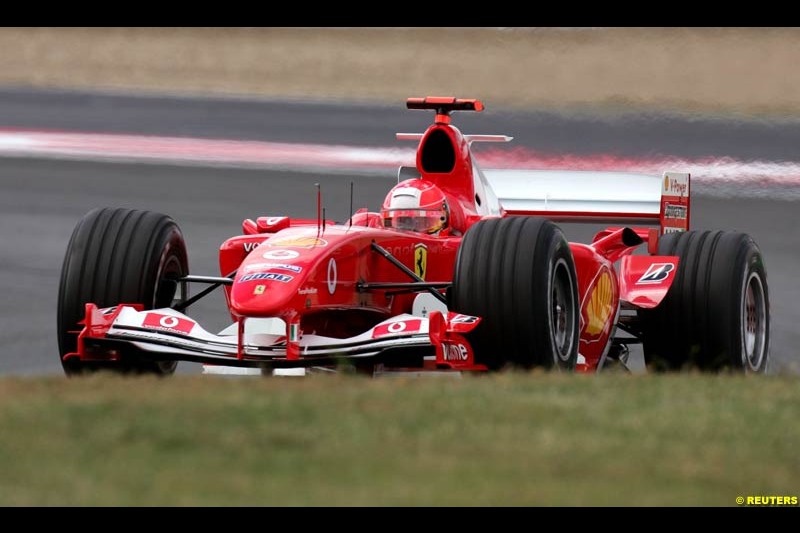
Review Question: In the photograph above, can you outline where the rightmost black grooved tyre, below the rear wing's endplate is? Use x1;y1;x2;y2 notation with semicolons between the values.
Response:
639;231;770;373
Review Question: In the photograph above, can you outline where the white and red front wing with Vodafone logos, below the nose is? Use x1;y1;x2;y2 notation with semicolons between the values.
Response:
64;303;486;370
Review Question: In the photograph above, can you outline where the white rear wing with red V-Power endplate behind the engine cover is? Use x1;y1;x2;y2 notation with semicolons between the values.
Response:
482;169;691;235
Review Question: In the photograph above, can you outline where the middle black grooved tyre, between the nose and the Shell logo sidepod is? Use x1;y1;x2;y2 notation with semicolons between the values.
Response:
448;217;579;370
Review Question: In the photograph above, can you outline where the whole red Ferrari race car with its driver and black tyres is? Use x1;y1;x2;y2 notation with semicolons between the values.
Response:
58;97;770;375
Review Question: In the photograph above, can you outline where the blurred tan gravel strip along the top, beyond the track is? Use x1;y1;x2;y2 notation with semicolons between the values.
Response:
0;27;800;117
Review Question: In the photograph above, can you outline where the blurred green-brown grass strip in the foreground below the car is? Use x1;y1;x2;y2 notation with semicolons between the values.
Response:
0;373;800;506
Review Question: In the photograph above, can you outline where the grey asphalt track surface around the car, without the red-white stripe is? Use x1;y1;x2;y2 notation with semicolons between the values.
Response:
0;89;800;375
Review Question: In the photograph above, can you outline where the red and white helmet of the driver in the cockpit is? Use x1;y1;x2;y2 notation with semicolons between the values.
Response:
381;178;449;234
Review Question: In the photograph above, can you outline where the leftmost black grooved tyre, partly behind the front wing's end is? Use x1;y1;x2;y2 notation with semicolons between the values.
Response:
57;208;189;376
